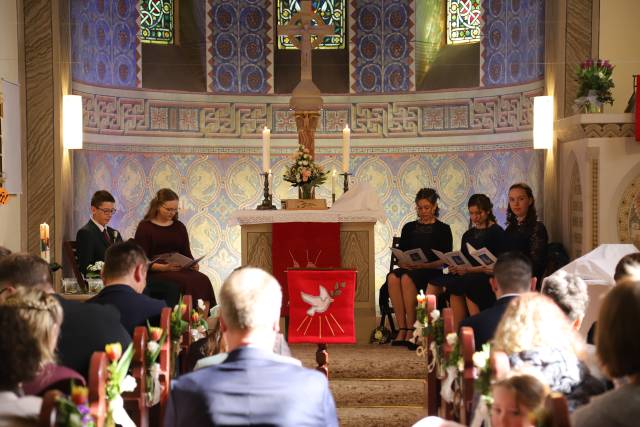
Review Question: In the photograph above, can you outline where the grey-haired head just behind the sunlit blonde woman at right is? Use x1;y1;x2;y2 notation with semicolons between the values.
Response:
542;271;589;330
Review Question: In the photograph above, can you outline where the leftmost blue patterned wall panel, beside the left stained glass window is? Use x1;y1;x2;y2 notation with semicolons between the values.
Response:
71;0;141;87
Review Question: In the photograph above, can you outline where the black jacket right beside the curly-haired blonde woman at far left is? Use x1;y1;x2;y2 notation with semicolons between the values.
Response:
56;295;131;378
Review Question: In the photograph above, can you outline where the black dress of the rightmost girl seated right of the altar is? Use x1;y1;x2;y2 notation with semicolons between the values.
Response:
504;221;549;289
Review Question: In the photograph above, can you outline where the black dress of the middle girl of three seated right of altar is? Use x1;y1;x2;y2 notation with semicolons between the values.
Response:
433;224;504;310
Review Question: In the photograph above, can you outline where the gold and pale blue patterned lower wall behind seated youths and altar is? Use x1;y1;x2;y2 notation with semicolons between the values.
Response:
73;146;542;300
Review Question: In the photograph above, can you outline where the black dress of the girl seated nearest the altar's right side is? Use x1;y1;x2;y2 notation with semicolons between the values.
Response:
391;220;453;291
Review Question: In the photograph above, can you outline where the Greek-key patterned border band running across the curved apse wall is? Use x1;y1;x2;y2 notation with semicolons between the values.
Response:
74;82;542;138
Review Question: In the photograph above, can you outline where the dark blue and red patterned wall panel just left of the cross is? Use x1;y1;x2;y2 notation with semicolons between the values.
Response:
206;0;273;94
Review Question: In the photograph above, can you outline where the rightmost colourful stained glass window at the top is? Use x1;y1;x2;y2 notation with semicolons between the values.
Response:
447;0;482;44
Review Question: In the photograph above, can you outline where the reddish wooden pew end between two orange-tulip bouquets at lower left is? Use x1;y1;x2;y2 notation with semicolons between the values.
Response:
122;326;149;427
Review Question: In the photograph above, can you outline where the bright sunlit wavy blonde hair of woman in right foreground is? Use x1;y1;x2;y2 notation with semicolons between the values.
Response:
491;292;583;355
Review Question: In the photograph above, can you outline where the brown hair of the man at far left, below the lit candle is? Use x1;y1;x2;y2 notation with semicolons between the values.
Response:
0;252;52;287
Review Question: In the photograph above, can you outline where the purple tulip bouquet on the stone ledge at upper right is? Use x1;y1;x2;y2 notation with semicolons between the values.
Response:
574;59;615;113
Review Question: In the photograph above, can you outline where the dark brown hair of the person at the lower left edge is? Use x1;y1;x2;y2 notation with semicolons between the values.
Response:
0;305;42;391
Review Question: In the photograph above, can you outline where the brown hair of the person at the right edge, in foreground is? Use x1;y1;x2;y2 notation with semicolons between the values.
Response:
596;280;640;378
